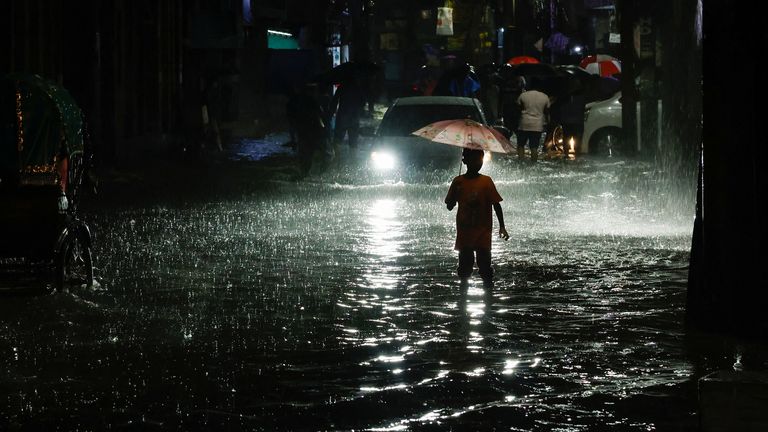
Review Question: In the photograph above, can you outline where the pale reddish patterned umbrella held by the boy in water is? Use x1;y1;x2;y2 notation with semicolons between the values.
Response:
411;119;515;153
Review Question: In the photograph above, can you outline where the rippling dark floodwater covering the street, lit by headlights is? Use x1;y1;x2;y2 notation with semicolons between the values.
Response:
0;147;756;431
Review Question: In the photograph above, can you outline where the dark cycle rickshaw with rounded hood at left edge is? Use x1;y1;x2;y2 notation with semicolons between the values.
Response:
0;74;93;291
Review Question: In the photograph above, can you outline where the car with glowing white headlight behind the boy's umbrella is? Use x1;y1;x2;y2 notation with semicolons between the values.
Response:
370;96;509;170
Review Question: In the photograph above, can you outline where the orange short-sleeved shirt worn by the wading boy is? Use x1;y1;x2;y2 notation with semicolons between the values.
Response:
445;174;503;250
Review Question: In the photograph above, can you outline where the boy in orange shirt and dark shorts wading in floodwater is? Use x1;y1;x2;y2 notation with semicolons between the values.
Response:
445;149;509;286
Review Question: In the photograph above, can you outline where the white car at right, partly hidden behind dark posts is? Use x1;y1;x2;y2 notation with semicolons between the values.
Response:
580;92;627;156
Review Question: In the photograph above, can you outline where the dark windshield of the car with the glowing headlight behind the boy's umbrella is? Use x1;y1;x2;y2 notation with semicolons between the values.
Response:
379;105;483;136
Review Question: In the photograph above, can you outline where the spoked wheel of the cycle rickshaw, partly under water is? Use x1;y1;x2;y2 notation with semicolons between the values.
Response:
56;235;93;292
